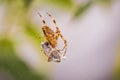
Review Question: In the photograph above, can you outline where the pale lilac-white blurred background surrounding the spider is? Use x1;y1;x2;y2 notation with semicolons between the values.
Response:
0;0;120;80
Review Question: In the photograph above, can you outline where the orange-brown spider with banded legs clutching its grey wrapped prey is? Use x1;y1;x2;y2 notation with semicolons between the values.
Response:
38;13;67;62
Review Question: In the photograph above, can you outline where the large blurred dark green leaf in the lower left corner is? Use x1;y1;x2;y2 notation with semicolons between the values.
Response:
0;39;46;80
